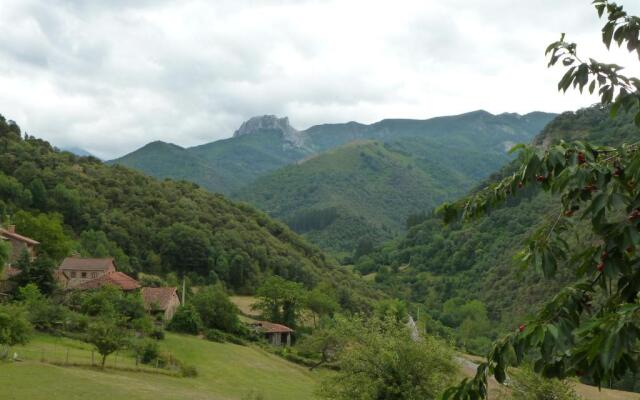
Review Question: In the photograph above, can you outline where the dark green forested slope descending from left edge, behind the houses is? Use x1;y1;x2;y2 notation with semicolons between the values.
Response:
0;117;376;308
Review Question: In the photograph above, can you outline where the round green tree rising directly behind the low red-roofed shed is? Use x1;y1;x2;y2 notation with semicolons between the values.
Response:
253;276;306;327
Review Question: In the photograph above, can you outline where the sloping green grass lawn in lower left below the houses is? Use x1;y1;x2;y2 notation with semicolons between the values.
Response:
0;334;320;400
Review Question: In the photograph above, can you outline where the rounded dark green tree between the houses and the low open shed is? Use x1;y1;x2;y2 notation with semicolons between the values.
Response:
191;286;240;333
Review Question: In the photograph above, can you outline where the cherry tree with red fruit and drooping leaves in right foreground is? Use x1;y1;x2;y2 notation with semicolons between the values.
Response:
438;0;640;399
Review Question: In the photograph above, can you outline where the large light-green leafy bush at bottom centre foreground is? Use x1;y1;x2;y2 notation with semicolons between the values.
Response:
319;319;457;400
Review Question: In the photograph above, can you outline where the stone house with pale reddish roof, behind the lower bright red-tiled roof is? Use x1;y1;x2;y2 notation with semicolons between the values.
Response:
56;257;116;288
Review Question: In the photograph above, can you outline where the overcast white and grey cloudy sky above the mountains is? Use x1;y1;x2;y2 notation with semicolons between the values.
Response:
0;0;640;158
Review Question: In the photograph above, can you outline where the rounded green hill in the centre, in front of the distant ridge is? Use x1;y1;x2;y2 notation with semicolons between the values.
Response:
234;141;470;253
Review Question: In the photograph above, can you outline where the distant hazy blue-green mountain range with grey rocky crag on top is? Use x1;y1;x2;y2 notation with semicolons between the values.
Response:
110;111;553;194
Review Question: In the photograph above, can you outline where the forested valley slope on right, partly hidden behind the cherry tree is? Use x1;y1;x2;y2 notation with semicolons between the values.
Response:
356;107;637;351
